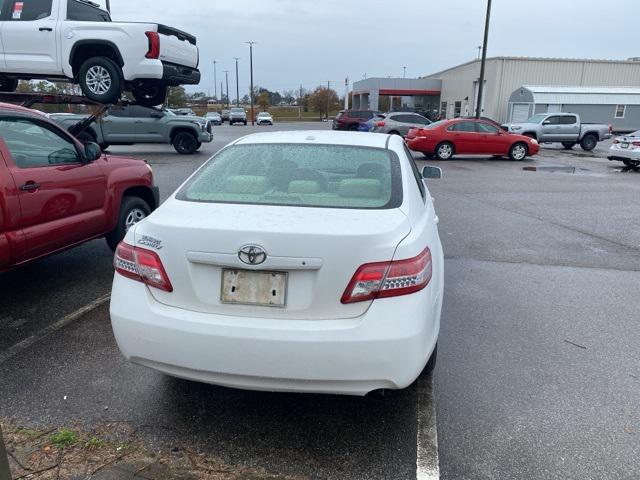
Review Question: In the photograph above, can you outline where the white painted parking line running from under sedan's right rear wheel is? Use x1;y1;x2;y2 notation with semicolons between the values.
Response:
416;375;440;480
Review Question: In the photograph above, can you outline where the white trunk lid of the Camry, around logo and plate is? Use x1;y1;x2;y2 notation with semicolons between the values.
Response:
135;199;410;320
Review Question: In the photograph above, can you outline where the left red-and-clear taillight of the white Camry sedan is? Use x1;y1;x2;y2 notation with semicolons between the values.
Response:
113;242;173;292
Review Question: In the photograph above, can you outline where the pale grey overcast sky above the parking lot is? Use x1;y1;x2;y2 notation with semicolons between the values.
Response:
110;0;640;97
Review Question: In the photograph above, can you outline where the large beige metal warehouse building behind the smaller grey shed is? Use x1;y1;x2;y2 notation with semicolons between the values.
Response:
424;57;640;124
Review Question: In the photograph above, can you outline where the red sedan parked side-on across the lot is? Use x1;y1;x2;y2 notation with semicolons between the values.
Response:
406;118;540;160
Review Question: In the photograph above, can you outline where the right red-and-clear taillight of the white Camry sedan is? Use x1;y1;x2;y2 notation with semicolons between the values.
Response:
341;248;432;303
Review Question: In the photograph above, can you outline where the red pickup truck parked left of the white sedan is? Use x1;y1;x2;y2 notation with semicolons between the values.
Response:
0;103;159;271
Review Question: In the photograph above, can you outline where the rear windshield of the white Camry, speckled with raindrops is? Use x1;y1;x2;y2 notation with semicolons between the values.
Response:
176;144;402;209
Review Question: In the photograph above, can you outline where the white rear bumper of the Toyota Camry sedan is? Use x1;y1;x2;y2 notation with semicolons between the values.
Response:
111;274;442;395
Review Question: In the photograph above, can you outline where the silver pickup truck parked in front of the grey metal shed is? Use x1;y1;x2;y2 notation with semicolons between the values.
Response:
503;113;611;151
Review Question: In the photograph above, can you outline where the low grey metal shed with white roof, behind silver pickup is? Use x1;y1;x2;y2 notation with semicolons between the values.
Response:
507;85;640;131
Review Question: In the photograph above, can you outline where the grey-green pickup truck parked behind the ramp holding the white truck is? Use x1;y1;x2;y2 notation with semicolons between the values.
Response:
49;105;213;155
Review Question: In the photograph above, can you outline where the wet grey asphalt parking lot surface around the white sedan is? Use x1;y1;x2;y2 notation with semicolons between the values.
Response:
0;123;640;479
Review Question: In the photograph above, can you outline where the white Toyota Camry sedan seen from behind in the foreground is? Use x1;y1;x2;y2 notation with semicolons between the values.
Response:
110;131;444;395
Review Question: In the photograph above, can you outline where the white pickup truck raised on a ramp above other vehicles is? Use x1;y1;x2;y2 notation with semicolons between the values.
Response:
0;0;200;106
